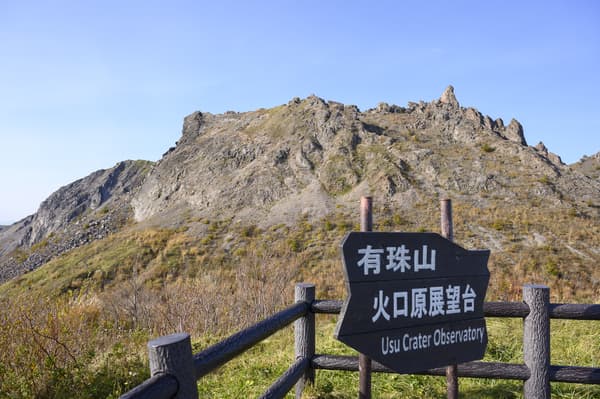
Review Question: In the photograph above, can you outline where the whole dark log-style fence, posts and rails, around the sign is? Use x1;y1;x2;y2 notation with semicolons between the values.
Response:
121;283;600;399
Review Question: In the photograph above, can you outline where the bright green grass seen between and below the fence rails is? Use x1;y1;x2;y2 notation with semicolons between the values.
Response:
198;315;600;399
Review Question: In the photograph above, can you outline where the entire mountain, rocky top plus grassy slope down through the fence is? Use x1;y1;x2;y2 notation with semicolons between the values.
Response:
0;93;600;398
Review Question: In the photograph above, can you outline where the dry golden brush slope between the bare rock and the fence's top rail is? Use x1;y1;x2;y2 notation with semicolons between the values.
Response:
0;203;600;398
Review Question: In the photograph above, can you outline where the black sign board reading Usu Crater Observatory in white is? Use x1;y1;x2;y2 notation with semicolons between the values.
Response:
335;232;490;373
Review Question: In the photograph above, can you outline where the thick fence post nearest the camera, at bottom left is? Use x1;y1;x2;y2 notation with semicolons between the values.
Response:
148;333;198;399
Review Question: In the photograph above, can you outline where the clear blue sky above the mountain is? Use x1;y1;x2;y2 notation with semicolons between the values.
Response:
0;0;600;224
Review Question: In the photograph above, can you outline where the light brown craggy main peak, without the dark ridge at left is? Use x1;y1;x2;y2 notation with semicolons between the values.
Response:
132;86;599;225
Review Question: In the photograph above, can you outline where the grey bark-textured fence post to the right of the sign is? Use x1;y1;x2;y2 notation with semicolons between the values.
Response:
523;284;550;399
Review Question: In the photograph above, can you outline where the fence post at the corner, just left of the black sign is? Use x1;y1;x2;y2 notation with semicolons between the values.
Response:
294;283;315;399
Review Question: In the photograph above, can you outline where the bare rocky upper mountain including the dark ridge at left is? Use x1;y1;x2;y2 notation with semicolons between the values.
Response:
0;86;600;286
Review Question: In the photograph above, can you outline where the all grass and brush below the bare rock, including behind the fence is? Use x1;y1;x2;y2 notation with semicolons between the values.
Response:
0;203;600;398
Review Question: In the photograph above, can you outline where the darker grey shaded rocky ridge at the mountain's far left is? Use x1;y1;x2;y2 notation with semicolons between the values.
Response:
0;161;151;281
